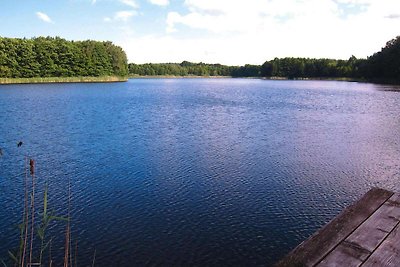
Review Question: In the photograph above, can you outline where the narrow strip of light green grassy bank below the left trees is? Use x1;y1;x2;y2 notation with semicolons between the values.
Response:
0;76;127;84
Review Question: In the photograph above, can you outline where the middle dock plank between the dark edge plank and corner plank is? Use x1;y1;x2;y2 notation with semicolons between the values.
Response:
317;194;400;267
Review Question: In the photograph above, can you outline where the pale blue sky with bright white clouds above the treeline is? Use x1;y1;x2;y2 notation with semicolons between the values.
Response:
0;0;400;65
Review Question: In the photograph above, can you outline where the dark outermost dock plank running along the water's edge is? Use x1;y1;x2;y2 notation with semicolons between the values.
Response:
276;188;393;267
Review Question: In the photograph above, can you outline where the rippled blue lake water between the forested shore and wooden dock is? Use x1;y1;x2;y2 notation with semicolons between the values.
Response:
0;79;400;266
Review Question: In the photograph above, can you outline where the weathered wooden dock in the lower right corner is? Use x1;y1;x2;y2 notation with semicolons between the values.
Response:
276;188;400;267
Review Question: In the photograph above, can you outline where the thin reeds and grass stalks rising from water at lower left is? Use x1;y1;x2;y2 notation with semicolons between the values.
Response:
0;142;90;267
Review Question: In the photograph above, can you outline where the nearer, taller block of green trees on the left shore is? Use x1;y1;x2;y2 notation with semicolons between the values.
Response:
0;37;128;78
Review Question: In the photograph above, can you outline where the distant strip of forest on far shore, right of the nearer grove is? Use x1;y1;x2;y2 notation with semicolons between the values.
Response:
129;36;400;82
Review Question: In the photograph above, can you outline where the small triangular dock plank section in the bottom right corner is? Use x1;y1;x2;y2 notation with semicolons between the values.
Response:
362;221;400;267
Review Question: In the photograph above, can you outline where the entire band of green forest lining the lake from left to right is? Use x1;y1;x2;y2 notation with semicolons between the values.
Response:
0;36;400;83
